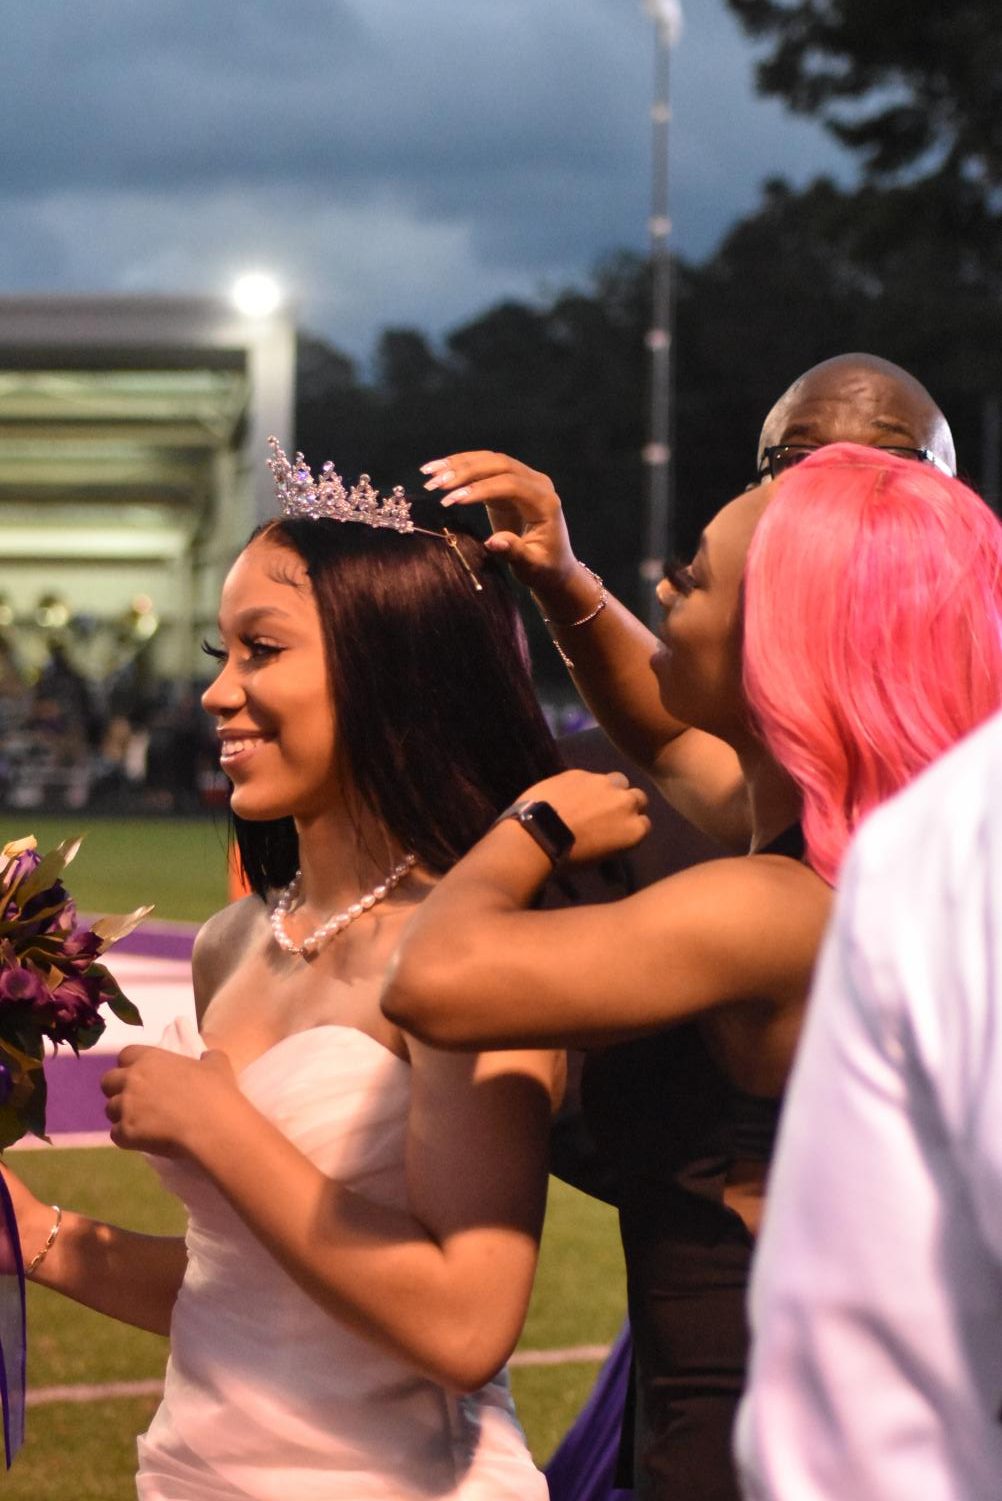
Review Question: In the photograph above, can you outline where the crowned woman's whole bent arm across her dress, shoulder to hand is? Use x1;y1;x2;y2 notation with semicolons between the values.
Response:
104;1045;555;1390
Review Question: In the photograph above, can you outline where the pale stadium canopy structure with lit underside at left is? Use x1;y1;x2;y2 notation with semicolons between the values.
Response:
0;297;294;669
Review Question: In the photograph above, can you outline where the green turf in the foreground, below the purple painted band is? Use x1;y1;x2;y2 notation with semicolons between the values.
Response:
0;1148;624;1501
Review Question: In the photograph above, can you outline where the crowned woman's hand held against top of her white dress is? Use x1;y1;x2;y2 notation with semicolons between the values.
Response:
101;1046;242;1157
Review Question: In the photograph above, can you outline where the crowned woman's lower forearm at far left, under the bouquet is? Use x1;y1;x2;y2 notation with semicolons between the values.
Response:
32;1210;188;1334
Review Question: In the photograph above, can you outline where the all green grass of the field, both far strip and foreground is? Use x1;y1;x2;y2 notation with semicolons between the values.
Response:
0;814;626;1501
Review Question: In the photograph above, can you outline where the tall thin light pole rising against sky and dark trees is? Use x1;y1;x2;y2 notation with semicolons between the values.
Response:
641;0;683;624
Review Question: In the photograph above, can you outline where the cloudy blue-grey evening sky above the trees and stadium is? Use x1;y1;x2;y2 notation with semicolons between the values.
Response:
0;0;849;356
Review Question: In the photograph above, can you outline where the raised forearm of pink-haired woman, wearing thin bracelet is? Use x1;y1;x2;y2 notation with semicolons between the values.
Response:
536;566;687;772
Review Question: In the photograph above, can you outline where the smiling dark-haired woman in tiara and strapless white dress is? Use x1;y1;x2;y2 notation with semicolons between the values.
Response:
0;440;560;1501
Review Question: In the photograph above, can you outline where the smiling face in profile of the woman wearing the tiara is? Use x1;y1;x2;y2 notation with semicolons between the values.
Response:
203;534;339;821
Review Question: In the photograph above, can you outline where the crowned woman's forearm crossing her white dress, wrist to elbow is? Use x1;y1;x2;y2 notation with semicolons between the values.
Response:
189;1097;536;1390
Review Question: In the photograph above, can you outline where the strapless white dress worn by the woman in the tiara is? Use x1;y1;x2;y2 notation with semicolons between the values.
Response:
137;1021;548;1501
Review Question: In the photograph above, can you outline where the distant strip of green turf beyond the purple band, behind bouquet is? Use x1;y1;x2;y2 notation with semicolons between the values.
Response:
2;811;227;923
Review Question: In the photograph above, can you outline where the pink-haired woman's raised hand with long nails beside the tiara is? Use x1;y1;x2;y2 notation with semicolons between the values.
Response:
422;449;581;602
